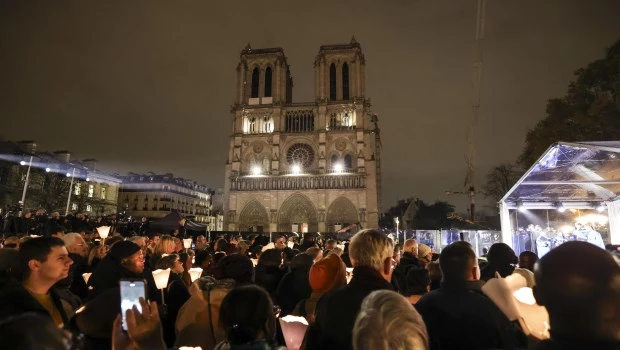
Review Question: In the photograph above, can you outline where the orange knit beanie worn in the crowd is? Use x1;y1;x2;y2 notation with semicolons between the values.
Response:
309;254;347;294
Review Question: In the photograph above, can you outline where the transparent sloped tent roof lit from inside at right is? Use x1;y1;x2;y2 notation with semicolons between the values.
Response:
502;141;620;209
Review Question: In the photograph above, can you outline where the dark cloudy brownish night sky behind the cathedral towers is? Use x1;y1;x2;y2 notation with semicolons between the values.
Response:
0;0;620;212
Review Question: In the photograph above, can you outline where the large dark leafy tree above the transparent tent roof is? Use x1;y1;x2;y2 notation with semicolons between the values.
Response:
518;40;620;168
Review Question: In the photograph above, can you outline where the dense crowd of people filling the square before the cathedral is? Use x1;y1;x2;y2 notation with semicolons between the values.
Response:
0;215;620;350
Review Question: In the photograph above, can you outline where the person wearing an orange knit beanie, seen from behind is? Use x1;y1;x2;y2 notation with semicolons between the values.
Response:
292;254;347;324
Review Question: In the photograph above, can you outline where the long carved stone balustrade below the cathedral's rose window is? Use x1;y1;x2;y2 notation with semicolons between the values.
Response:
230;174;366;191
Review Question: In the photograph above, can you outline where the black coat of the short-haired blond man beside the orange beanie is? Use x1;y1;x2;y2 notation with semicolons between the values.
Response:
306;267;392;349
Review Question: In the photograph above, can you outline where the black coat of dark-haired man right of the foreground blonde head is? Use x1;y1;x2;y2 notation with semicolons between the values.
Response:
415;281;516;350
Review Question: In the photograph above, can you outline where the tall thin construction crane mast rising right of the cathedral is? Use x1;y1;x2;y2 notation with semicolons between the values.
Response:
463;0;486;222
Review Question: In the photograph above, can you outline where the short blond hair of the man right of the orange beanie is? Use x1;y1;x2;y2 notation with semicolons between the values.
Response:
349;230;394;271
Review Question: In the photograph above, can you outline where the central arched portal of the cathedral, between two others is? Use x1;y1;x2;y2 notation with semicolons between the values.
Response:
278;193;319;232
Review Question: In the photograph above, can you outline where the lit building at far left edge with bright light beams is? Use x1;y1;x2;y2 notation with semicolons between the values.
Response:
0;141;121;216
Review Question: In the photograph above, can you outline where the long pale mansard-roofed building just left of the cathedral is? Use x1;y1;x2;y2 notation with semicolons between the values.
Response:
118;173;216;223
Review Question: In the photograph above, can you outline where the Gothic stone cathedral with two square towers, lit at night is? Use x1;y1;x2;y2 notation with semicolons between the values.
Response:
224;38;381;232
